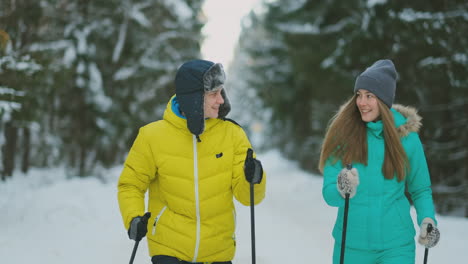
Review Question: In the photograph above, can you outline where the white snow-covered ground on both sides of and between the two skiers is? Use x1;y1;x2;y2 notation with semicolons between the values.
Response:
0;151;468;264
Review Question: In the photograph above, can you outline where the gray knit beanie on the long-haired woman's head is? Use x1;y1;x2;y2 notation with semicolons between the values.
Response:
354;60;398;108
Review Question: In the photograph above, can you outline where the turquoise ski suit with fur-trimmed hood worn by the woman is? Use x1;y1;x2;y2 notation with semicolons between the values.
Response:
322;105;436;264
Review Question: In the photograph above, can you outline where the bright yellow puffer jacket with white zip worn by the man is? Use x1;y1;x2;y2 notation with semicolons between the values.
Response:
118;97;266;262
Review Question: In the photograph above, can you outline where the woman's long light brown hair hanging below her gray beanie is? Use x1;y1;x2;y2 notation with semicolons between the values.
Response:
319;95;409;181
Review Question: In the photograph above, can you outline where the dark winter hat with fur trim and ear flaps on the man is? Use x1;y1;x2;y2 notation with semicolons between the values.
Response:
175;60;231;136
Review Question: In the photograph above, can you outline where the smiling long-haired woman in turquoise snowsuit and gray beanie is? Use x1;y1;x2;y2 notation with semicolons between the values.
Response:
319;60;439;264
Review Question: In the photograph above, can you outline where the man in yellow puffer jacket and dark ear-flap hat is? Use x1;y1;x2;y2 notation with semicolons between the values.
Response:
118;60;266;264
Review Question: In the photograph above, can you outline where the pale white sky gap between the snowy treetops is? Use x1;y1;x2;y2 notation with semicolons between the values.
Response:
202;0;260;68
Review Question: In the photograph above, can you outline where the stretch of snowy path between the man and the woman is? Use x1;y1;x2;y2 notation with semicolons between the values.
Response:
235;153;335;264
